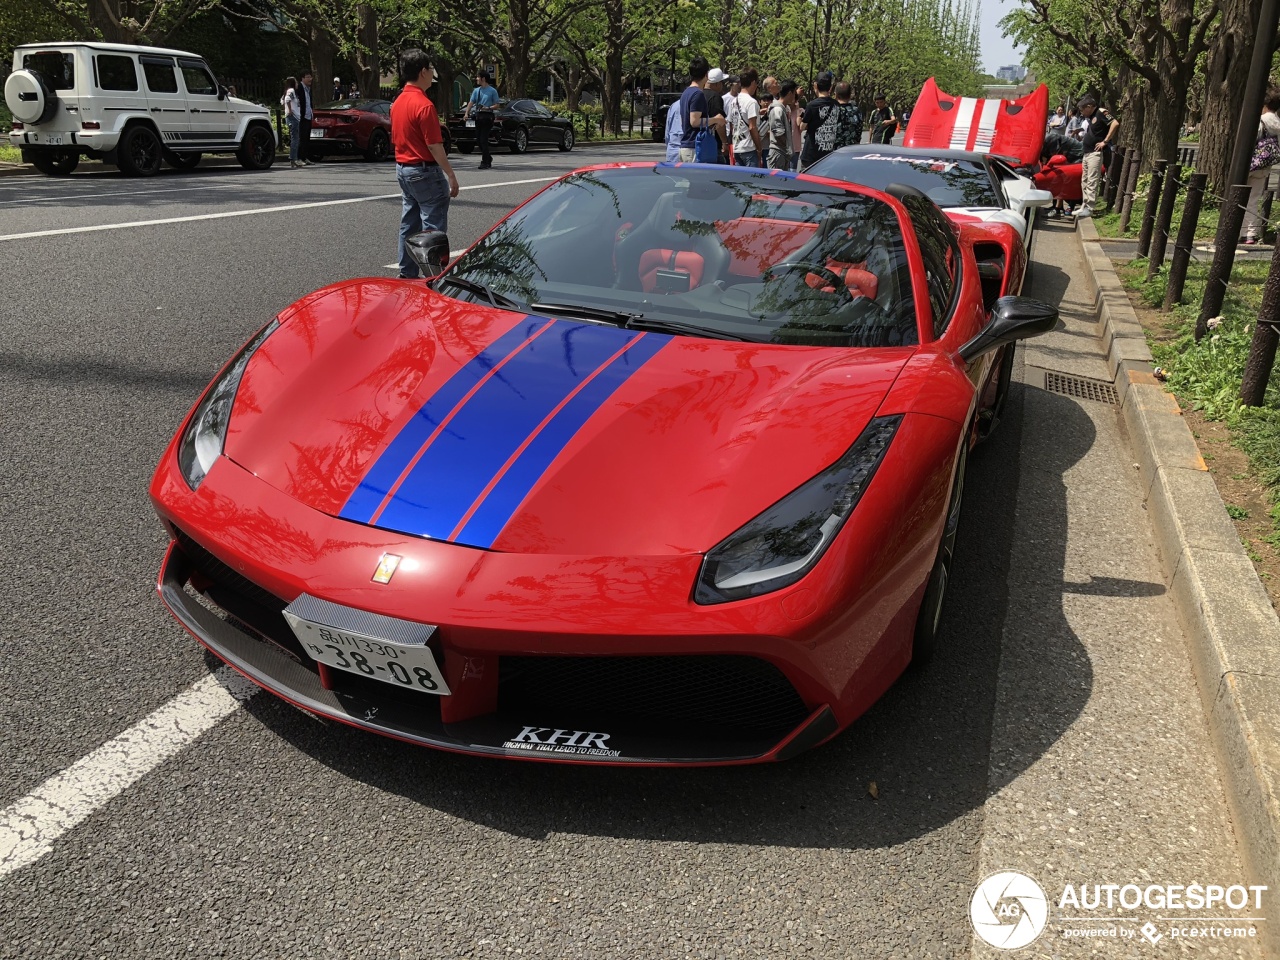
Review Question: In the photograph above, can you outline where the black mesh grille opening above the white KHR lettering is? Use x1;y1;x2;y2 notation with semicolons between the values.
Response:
498;655;809;736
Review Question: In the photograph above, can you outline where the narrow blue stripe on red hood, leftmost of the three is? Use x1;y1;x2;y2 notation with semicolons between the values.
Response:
339;316;548;524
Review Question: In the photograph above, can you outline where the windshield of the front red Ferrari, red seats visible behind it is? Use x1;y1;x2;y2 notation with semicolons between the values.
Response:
439;164;918;347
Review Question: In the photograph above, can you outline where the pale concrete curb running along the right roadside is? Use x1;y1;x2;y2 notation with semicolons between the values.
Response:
1078;220;1280;956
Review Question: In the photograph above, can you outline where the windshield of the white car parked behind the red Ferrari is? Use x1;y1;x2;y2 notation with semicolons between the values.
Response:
809;154;1005;207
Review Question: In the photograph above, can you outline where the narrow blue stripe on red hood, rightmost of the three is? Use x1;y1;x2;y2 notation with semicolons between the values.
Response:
454;333;671;547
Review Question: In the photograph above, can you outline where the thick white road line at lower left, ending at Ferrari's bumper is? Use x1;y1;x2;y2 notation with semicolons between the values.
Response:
0;667;259;877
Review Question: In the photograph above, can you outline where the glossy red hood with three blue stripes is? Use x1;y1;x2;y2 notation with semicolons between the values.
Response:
225;280;913;556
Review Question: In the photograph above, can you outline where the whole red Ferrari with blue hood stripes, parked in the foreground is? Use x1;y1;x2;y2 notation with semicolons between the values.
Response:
151;164;1057;764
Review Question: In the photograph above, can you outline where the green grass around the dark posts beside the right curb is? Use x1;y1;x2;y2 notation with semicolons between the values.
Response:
1119;261;1280;537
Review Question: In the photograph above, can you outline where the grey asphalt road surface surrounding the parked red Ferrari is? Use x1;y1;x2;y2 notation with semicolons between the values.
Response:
0;147;1261;959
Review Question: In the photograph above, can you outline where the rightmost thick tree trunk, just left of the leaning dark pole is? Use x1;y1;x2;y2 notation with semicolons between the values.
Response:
1196;0;1262;195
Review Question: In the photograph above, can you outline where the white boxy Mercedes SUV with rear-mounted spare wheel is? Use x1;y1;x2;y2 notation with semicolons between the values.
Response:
4;44;276;177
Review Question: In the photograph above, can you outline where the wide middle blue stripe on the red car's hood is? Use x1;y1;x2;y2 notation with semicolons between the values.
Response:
374;321;650;540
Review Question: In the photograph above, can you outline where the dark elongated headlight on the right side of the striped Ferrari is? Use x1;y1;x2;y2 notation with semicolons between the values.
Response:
694;415;902;604
